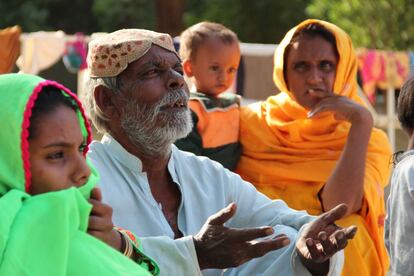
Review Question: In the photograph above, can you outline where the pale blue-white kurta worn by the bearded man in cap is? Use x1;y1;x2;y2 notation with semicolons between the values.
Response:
88;135;343;276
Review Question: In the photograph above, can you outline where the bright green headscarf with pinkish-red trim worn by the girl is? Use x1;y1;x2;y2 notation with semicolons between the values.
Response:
0;74;158;276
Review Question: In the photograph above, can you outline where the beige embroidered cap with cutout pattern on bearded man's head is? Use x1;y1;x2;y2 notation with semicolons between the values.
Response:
87;29;179;77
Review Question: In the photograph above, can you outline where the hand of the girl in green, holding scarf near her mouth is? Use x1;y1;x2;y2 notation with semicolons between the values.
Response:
88;188;122;251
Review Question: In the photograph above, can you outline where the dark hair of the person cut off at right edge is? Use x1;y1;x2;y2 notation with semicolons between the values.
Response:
397;76;414;134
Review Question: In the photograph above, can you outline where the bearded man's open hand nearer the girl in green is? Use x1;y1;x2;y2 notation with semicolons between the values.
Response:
194;203;290;269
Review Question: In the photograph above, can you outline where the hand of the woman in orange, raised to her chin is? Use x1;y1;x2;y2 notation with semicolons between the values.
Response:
308;88;373;126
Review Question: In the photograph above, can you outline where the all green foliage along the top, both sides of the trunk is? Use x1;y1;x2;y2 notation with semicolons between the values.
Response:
0;0;414;50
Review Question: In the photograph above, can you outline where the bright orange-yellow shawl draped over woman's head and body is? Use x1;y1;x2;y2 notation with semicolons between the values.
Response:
237;19;391;276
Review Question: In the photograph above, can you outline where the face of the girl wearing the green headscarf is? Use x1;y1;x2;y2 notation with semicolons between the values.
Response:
29;105;91;194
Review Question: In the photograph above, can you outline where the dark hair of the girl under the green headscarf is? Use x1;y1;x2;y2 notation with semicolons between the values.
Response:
29;86;77;140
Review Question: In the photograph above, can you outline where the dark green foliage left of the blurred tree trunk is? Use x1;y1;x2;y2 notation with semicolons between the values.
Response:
0;0;155;33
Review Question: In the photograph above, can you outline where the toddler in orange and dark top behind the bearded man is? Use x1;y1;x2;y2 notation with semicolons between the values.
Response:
175;22;241;170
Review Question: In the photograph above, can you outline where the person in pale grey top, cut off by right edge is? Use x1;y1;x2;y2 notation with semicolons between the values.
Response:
385;76;414;275
